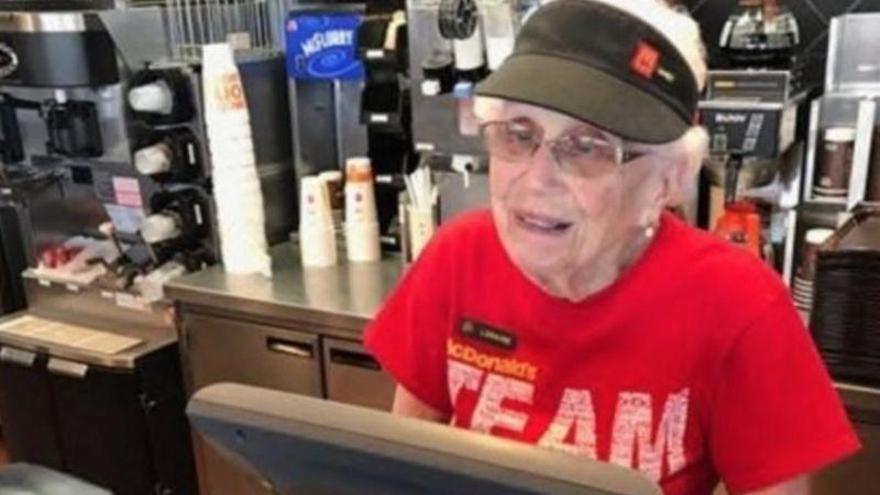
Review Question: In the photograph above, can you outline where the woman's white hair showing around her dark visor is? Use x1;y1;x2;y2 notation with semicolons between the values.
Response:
474;0;709;206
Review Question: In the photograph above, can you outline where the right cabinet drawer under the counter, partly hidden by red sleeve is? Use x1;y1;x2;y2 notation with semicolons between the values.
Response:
323;338;394;411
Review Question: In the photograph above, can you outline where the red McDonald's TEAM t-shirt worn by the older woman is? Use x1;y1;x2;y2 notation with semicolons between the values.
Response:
366;211;859;495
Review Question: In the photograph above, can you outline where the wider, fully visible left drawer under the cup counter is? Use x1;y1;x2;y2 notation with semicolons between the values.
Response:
183;313;323;397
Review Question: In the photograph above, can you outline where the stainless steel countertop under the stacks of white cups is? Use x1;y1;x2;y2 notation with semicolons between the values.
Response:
165;242;403;338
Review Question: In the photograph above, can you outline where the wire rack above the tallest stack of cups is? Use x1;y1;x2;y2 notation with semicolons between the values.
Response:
165;0;291;61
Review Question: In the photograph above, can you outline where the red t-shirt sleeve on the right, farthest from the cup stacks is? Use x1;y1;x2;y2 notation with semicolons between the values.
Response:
709;293;859;493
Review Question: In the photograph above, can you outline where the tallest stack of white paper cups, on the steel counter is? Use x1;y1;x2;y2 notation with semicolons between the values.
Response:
202;43;272;276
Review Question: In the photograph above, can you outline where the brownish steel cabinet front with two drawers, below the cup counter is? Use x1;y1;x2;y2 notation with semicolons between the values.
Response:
179;307;394;495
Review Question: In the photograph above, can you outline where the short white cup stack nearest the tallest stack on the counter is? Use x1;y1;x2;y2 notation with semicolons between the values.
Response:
299;177;336;267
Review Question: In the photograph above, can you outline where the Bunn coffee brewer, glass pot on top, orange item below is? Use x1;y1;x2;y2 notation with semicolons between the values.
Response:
699;0;813;265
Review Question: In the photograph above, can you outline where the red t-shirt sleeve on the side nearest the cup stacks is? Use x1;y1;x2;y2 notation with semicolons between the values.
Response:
364;229;454;413
